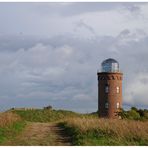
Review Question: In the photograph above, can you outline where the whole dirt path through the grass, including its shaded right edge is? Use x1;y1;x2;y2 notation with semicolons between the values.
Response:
4;122;71;146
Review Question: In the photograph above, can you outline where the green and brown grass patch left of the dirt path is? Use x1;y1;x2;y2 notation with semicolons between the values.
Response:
0;112;25;145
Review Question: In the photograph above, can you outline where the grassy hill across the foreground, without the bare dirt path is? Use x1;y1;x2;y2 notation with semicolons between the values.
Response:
0;109;148;145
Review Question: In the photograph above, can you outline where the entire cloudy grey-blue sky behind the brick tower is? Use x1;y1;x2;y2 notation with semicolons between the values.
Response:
0;2;148;112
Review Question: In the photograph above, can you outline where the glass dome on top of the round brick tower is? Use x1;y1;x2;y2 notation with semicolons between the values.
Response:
101;58;119;72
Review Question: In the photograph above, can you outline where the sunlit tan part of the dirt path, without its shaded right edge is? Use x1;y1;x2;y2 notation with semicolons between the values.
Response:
2;122;65;146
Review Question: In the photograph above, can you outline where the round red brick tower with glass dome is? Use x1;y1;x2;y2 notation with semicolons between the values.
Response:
97;58;123;118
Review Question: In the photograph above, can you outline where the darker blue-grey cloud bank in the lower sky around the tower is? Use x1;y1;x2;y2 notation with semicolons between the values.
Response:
0;27;148;112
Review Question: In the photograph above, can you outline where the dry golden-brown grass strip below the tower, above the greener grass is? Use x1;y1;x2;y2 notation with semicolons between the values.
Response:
66;117;148;141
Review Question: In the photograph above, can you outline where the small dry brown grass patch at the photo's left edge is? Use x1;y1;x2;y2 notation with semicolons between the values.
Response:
0;112;21;128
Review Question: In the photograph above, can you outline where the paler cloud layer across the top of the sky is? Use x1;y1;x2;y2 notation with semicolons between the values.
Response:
0;2;148;36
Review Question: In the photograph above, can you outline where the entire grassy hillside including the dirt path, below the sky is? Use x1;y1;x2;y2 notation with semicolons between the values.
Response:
0;109;148;146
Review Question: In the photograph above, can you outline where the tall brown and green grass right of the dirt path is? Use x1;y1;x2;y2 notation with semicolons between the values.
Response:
59;117;148;145
